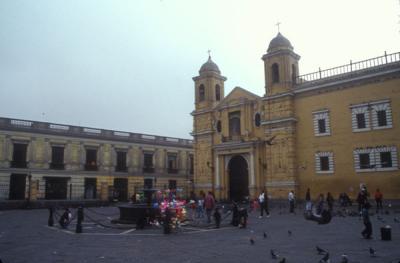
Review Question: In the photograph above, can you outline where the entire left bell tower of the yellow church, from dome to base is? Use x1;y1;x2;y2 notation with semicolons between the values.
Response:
192;55;226;196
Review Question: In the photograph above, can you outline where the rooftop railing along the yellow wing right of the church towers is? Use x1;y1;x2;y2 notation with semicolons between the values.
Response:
296;52;400;85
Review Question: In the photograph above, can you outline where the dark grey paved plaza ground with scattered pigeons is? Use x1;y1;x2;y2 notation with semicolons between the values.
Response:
0;207;400;263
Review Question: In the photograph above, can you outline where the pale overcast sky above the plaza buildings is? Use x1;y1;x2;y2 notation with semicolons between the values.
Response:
0;0;400;138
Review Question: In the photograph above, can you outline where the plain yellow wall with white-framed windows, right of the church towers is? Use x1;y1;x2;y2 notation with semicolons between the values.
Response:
295;79;400;198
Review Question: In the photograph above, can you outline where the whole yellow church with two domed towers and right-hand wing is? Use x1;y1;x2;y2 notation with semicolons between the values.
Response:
192;33;400;200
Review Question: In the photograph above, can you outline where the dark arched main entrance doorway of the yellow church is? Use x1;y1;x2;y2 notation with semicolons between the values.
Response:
228;155;249;201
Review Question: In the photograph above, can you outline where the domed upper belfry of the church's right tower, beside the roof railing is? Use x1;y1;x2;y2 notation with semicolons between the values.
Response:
262;32;300;97
